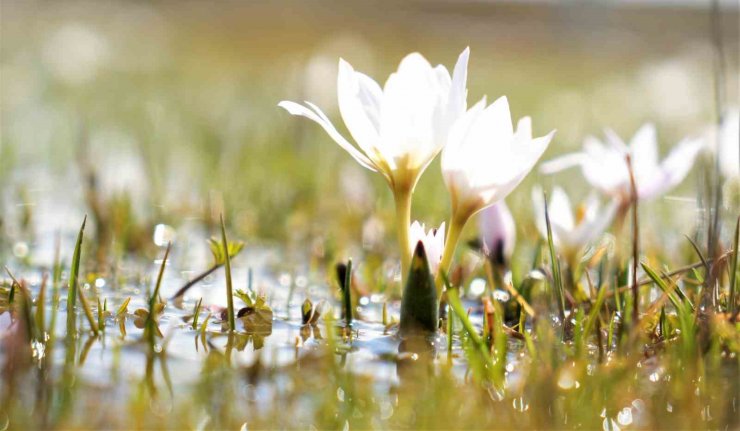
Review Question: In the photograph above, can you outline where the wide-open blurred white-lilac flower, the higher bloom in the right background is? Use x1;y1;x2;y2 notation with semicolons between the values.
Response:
541;124;703;202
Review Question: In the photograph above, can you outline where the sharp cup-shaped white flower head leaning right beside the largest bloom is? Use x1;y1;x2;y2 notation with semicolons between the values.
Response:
442;97;555;219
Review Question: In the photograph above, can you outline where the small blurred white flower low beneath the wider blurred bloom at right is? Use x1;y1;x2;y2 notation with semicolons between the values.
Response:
532;187;618;256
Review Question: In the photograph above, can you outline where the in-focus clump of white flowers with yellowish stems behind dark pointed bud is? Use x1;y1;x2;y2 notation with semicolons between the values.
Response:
279;49;553;296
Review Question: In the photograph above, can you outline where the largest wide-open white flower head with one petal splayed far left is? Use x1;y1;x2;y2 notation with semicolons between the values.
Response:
279;49;469;191
